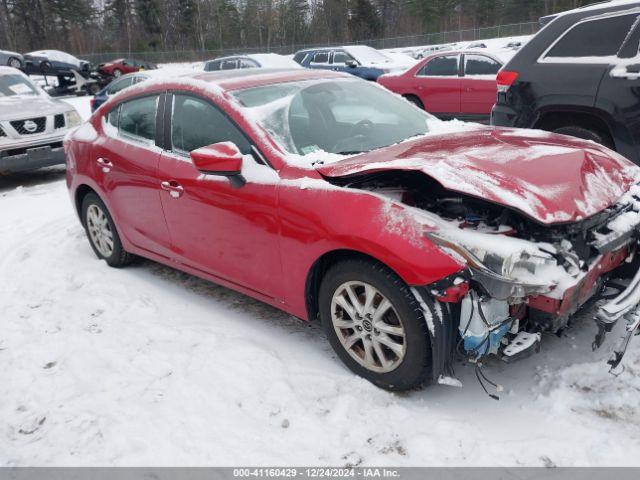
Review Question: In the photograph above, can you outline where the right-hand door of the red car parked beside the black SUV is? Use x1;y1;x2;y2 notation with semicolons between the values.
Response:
460;53;502;121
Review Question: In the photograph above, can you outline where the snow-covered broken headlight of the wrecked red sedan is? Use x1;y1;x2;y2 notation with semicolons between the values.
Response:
427;233;557;299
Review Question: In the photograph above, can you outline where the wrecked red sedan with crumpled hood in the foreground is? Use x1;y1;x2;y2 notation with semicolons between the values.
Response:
65;70;640;390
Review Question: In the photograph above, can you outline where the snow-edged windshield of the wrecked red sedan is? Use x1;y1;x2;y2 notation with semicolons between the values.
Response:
233;79;431;155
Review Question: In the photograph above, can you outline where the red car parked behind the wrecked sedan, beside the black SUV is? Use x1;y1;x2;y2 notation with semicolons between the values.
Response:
378;50;514;123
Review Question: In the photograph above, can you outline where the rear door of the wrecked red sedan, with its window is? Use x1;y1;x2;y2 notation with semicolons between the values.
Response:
93;95;170;258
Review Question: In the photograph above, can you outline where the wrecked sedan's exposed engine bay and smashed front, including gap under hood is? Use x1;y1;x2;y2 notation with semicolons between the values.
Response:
330;171;640;386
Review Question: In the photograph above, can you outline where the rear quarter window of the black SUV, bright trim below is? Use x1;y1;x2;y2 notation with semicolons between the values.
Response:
545;15;638;58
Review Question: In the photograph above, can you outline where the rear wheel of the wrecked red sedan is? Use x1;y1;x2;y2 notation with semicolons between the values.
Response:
82;193;133;268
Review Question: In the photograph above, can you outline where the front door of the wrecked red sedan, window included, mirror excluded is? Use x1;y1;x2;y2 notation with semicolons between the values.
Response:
159;93;282;298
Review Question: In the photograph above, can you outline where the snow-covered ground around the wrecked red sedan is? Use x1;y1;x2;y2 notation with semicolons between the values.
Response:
0;97;640;466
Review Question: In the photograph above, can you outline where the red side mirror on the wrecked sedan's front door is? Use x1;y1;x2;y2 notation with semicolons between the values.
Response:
189;142;247;188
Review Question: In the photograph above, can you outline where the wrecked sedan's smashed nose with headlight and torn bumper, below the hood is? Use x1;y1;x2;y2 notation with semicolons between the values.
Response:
426;186;640;376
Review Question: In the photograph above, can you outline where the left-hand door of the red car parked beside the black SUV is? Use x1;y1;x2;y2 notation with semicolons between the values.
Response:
415;54;462;118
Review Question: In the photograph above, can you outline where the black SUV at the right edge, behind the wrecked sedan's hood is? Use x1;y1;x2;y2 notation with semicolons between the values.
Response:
491;1;640;164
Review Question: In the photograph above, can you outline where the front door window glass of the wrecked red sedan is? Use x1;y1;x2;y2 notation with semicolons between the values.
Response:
171;95;251;154
